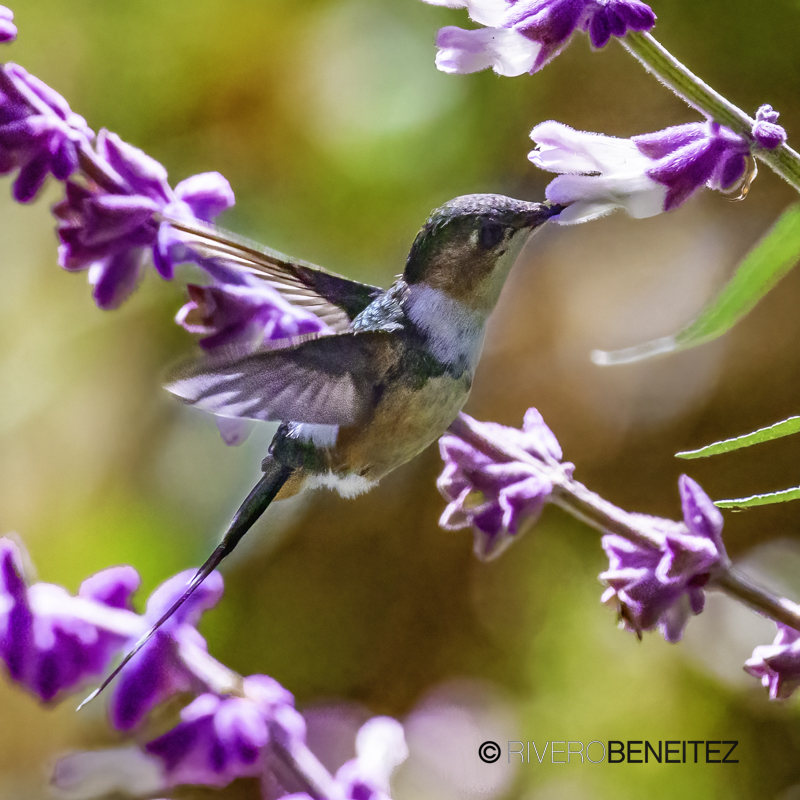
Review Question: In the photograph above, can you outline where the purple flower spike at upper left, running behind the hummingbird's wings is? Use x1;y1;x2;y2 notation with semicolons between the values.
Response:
0;6;327;351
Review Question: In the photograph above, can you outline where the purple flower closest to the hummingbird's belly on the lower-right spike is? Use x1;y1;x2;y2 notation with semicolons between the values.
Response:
436;408;572;560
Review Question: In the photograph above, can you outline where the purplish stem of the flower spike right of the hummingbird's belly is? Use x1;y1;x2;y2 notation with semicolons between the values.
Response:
448;414;800;631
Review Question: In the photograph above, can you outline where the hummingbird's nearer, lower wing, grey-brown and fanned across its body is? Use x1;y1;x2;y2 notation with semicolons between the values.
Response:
166;332;399;425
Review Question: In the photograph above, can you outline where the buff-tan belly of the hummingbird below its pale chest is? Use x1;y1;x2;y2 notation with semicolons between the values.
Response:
329;373;472;488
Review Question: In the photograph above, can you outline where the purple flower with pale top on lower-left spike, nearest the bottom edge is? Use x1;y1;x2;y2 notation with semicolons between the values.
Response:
144;675;305;786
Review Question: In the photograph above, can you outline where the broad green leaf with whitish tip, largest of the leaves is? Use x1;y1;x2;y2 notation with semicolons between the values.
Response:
592;203;800;366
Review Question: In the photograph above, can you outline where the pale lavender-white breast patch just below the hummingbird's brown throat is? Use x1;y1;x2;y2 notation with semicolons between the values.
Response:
406;283;486;368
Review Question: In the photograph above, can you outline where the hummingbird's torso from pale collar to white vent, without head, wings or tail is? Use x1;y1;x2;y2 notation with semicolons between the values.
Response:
271;279;485;497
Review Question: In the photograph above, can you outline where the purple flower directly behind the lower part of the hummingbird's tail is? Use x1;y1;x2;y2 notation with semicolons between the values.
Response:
109;569;223;731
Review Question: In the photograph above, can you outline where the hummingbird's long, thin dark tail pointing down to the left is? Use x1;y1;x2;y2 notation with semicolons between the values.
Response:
78;459;294;710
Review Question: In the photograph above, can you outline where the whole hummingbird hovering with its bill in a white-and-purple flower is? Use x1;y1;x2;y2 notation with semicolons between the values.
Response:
84;194;563;703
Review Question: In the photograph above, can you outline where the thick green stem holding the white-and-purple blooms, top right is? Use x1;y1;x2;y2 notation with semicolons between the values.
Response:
620;33;800;192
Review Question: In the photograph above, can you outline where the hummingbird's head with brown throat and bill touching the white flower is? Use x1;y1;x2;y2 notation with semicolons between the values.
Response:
403;194;562;313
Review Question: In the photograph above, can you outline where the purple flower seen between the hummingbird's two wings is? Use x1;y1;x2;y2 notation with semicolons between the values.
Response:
175;279;329;352
